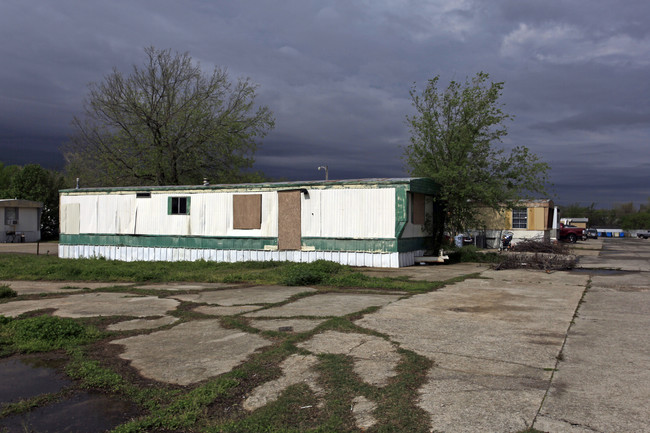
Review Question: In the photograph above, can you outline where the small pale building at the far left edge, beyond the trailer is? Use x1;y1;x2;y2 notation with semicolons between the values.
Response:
0;199;43;242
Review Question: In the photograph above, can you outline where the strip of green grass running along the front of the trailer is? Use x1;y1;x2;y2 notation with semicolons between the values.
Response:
0;255;450;292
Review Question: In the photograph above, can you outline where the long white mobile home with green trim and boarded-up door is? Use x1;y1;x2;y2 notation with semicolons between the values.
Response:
59;178;438;267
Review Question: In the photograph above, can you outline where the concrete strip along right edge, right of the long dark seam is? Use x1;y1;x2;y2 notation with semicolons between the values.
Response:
534;240;650;433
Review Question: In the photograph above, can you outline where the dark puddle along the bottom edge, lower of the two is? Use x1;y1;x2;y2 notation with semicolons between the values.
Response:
0;392;137;433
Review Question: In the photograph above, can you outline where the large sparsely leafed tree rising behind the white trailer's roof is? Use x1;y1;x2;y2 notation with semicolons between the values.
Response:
63;47;274;186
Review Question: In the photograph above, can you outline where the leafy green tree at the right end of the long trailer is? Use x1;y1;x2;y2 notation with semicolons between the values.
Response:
404;72;549;248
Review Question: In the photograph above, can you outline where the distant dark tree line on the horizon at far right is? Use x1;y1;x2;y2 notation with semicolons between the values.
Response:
561;202;650;230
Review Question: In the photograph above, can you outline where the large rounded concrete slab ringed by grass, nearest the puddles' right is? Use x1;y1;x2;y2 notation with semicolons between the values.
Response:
111;320;271;385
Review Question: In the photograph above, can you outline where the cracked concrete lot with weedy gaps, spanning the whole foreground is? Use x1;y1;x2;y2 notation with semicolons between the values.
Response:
0;239;650;433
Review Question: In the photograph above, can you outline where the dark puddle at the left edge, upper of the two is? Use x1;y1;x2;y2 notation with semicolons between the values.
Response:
0;358;72;403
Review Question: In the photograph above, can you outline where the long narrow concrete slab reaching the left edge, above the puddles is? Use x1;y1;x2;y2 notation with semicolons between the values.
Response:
0;292;180;318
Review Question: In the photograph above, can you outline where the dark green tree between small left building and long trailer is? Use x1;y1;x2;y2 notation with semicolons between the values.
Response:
8;164;64;240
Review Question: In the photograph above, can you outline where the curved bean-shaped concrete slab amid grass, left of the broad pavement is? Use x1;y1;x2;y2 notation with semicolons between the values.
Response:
298;331;401;387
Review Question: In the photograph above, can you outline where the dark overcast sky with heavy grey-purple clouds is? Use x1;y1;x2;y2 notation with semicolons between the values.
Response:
0;0;650;207
